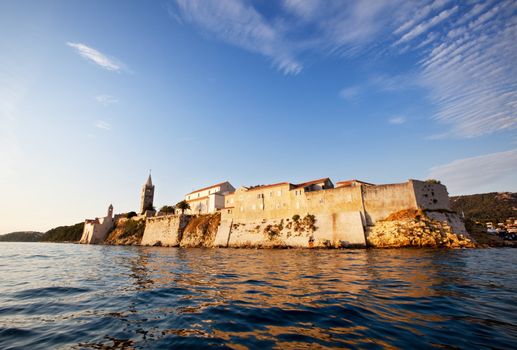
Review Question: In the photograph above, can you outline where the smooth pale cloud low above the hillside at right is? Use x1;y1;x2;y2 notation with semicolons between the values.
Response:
428;149;517;194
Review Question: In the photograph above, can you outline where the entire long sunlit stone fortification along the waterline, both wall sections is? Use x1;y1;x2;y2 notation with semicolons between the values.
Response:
138;180;466;247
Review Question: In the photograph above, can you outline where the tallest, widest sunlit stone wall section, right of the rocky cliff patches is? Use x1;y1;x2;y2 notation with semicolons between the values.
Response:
214;180;458;247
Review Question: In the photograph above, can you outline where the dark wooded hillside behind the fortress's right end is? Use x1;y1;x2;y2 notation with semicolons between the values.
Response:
451;192;517;222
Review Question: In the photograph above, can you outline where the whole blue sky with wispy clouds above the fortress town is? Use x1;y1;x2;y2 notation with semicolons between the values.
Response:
0;0;517;233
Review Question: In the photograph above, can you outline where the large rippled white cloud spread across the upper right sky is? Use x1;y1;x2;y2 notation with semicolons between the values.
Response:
171;0;517;138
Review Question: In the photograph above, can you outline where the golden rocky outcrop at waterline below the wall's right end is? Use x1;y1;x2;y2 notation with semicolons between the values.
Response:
366;209;476;248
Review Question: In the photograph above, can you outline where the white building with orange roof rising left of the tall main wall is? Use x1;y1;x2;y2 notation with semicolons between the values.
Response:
185;181;235;214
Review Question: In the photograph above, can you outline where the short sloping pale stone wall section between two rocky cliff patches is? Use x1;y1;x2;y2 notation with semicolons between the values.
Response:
141;215;189;247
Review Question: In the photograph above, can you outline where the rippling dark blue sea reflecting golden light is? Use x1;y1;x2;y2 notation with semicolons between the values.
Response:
0;243;517;350
